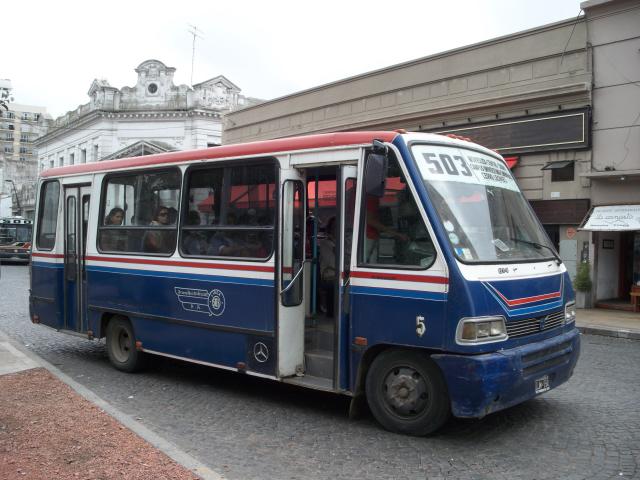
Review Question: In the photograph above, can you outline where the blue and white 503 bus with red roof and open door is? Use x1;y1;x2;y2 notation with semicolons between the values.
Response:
30;132;580;435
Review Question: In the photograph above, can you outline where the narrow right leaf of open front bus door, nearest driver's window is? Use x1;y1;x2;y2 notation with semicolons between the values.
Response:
333;165;358;390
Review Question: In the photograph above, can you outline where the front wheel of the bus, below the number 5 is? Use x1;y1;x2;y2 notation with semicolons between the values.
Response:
366;350;451;436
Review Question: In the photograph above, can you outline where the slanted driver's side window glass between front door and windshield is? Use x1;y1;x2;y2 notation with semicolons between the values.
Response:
358;152;435;268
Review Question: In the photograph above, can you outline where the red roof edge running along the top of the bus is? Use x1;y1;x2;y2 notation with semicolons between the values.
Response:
40;131;398;177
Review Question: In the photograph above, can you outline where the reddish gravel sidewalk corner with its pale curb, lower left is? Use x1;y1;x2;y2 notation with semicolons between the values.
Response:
0;331;222;480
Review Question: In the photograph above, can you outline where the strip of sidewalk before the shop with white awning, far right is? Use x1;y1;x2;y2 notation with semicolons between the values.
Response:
576;308;640;340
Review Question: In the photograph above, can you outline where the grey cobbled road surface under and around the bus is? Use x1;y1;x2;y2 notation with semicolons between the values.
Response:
0;265;640;480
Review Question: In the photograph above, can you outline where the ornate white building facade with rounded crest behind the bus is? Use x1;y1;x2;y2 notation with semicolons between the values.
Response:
36;60;258;170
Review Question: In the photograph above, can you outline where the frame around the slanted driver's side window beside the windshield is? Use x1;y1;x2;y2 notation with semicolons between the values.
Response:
356;145;439;272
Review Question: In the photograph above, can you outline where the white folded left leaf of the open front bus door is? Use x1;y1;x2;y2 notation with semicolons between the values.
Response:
277;174;305;377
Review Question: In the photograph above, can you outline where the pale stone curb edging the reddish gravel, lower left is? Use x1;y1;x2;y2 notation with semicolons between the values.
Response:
0;330;225;480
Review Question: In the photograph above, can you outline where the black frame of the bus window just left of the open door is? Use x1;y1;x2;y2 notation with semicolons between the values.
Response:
178;156;281;263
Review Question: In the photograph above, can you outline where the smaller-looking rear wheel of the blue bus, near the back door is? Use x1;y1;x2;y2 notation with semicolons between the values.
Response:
107;317;145;373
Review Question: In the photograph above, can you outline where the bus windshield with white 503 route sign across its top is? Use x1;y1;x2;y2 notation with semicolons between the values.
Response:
412;144;556;263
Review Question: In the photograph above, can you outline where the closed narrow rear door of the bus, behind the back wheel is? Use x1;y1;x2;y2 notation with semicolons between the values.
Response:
64;185;91;332
